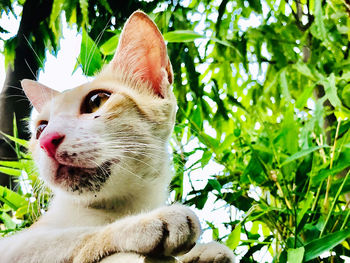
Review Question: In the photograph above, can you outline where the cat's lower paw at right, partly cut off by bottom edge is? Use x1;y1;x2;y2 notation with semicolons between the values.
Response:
179;242;235;263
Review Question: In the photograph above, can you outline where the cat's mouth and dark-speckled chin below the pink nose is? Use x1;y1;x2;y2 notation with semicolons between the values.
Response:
55;161;115;194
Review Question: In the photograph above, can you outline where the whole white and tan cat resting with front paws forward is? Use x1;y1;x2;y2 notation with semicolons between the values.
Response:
0;11;233;263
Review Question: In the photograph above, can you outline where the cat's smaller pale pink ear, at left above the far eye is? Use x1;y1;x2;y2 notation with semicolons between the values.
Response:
21;79;59;112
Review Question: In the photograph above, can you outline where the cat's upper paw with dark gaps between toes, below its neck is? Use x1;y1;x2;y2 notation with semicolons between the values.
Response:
122;205;201;256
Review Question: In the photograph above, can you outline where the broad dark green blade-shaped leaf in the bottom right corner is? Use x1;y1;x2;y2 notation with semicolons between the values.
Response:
304;229;350;261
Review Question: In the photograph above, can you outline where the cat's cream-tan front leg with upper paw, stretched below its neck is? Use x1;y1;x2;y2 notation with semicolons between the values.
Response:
74;205;200;263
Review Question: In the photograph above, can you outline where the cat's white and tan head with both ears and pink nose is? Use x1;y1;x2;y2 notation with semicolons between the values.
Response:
22;11;176;203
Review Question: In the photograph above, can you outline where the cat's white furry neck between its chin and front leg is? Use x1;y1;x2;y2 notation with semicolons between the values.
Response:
39;177;167;228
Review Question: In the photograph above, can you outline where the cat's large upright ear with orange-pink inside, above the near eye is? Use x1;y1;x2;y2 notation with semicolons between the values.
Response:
111;11;173;97
